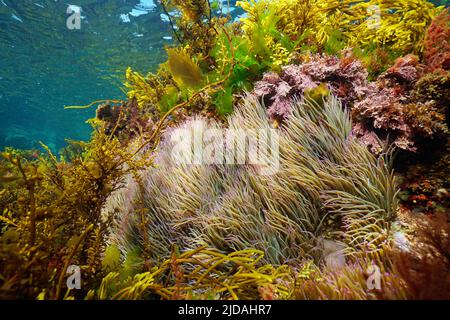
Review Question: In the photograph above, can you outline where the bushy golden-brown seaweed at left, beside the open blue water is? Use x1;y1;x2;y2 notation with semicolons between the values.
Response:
0;128;153;299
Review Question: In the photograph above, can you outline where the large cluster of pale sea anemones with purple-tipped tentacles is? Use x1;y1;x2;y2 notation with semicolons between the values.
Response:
108;96;396;265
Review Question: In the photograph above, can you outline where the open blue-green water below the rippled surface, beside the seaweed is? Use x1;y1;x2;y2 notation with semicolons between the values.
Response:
0;0;448;150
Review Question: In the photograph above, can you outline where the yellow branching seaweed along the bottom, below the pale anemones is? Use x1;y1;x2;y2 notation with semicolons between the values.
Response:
91;248;293;300
